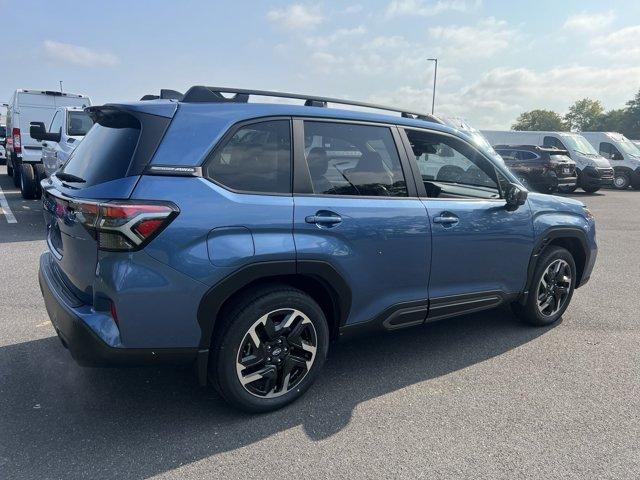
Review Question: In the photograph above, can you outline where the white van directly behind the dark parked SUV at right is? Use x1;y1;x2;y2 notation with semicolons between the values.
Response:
482;130;613;193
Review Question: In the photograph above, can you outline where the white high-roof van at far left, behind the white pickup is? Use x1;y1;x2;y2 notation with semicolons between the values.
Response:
6;89;91;196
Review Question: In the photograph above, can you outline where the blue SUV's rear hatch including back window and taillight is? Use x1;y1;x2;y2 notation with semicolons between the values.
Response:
42;105;175;303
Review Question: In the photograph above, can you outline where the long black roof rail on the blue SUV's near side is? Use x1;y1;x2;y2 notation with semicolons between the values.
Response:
181;85;444;124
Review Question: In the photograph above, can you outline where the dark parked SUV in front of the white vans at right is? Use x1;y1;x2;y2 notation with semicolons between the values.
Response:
494;145;578;193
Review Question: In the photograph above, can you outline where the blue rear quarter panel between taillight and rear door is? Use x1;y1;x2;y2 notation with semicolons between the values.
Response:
132;176;295;286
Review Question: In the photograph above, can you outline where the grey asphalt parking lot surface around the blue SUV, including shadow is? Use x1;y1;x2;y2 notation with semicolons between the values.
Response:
0;163;640;479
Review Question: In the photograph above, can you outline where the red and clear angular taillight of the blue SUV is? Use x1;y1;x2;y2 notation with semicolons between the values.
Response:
65;200;178;251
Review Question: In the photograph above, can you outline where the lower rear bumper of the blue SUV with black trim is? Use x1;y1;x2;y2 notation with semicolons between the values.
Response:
38;252;197;366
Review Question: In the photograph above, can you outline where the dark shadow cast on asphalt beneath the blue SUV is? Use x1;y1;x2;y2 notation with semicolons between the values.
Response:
0;310;551;479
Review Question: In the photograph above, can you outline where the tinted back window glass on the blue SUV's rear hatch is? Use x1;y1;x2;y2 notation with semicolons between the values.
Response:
62;115;140;187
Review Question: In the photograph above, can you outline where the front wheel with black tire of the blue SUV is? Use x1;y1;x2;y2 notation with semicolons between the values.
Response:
512;246;576;326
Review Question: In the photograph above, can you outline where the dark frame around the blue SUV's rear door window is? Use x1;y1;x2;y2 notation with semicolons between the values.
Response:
293;116;418;200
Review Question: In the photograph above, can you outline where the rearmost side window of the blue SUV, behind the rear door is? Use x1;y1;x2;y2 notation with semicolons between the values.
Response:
205;120;291;194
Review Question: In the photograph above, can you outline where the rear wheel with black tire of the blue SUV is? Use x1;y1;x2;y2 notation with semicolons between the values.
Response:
209;286;329;413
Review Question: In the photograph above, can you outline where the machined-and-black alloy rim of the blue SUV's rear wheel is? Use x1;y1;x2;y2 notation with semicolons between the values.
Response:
236;308;318;398
